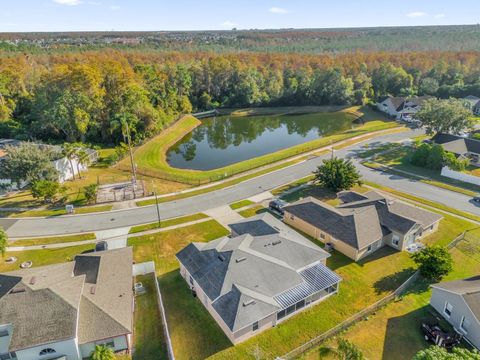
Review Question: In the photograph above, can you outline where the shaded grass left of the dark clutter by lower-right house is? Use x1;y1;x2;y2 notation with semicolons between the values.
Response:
382;305;431;360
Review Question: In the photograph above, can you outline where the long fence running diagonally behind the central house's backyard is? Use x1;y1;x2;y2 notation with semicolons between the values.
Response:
279;271;420;360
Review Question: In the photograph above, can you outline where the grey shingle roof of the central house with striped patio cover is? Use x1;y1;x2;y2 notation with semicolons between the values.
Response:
177;214;340;332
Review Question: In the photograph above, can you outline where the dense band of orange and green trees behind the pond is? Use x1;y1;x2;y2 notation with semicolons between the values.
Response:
0;50;480;144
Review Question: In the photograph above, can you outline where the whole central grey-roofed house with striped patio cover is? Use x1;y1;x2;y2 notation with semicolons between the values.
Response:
176;214;340;344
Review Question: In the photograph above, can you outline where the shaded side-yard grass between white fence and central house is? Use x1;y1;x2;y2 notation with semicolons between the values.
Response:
159;270;233;359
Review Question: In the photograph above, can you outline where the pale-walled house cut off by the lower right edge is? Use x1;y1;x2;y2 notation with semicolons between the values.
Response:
430;276;480;350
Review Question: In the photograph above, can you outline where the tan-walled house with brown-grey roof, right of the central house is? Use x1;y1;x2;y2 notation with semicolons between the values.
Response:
284;191;442;261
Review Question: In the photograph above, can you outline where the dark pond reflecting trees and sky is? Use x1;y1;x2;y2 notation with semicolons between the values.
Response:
167;112;355;170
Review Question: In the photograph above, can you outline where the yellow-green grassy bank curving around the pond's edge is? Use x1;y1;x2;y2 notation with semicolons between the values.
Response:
124;107;397;185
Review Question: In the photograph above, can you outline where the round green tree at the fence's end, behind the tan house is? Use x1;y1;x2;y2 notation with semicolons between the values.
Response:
411;246;453;281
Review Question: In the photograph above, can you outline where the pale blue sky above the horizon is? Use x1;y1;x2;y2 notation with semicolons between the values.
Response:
0;0;480;32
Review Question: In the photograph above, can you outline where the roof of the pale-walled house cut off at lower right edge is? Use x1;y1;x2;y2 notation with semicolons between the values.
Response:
432;276;480;321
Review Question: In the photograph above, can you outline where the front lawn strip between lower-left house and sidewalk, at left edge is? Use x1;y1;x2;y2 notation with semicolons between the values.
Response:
0;244;94;272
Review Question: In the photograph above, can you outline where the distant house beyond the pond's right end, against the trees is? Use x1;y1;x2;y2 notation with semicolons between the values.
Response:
377;96;433;121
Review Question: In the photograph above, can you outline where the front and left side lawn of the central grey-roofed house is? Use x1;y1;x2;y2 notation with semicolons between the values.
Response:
128;220;230;359
